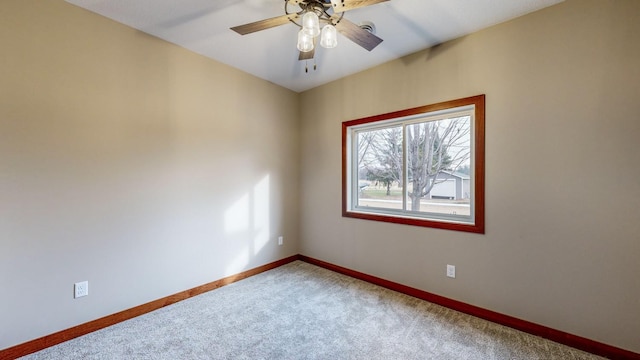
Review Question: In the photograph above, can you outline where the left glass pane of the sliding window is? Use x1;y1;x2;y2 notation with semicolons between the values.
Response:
355;126;403;210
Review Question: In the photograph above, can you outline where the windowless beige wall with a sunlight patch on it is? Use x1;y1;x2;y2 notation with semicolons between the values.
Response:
0;0;299;349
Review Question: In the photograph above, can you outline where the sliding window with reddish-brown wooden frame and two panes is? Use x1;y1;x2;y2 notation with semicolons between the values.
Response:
342;95;485;233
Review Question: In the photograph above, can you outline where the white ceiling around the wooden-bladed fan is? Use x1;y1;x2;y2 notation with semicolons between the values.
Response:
67;0;563;92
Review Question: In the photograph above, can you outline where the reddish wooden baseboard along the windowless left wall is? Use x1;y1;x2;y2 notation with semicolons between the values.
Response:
0;255;300;360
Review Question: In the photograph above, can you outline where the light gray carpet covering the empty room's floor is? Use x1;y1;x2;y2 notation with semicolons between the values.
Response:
22;261;601;360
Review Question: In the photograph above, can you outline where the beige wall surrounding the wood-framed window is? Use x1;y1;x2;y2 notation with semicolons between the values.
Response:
300;0;640;352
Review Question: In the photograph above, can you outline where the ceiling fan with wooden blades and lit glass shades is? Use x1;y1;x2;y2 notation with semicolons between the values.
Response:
231;0;389;60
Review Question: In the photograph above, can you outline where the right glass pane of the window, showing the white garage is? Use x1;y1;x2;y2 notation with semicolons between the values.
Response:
405;116;472;217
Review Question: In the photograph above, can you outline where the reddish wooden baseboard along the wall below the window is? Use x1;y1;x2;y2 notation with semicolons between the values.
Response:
299;255;640;360
